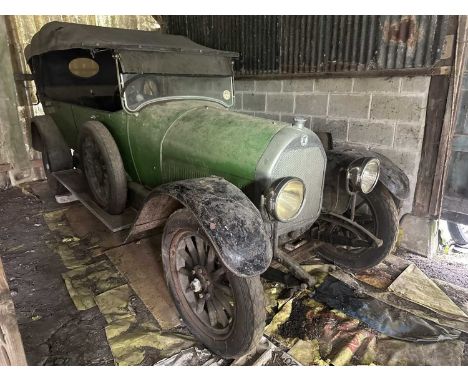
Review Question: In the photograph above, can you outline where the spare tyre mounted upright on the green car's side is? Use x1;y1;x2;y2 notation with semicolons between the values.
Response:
80;121;127;215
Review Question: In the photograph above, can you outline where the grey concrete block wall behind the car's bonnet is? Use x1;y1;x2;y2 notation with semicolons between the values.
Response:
234;76;430;213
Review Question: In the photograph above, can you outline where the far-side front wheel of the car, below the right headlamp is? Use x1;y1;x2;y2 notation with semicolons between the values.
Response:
318;183;398;271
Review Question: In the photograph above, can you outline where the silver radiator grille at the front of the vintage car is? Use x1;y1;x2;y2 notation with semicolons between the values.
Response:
272;146;325;234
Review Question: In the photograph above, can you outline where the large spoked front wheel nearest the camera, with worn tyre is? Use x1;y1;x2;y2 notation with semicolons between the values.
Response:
162;209;265;358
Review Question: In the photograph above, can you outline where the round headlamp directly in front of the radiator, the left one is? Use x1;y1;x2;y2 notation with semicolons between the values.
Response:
267;177;305;222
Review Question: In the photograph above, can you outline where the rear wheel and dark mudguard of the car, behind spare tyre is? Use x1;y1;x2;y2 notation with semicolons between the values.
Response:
31;115;73;195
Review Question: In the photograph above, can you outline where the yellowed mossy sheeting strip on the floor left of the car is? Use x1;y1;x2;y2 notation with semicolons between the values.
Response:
44;207;194;365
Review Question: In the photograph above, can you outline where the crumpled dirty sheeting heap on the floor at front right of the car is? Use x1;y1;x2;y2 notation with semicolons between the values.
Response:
265;256;468;365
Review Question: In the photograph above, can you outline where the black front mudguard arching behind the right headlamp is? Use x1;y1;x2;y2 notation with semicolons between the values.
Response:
322;147;410;214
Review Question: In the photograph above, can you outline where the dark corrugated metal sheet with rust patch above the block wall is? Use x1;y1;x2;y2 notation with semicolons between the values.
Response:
163;15;450;75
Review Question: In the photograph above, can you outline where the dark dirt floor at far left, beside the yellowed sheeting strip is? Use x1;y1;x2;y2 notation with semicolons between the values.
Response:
0;188;114;365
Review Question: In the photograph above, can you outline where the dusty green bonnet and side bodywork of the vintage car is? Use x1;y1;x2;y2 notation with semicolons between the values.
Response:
46;100;287;188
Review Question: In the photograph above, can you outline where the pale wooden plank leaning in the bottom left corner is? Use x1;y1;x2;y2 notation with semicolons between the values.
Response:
0;259;27;366
